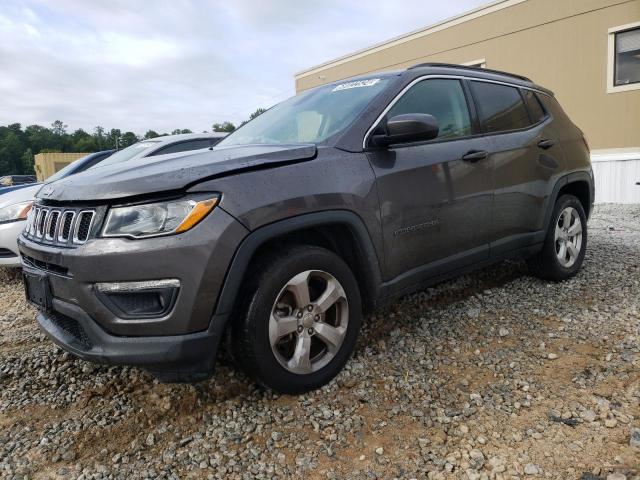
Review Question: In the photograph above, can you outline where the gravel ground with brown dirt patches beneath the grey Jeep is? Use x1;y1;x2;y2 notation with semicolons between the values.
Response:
0;206;640;480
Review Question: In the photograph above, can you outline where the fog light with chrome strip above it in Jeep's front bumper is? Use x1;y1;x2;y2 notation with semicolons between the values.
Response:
96;279;180;319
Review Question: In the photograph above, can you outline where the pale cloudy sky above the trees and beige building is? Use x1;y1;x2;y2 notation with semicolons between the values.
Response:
0;0;486;135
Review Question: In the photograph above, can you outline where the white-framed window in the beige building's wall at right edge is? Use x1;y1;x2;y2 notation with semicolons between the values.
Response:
607;22;640;93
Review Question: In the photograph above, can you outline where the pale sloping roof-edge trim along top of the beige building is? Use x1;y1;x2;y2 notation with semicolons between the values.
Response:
295;0;527;78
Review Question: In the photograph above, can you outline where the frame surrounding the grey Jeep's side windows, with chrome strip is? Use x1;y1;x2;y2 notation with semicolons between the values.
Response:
362;74;553;151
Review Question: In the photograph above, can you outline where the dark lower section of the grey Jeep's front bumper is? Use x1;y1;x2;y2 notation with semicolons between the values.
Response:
36;299;227;381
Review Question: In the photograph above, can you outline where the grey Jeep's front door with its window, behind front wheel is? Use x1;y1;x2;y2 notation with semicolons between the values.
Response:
368;78;493;283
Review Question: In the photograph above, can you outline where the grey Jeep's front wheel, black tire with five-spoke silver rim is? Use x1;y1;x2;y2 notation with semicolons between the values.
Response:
230;245;362;394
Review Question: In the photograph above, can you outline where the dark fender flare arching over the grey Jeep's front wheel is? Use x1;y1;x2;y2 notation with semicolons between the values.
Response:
214;210;382;317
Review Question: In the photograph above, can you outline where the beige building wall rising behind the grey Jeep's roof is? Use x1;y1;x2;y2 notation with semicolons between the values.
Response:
296;0;640;149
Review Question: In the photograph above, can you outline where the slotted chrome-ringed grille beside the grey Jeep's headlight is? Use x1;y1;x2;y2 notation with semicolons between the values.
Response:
24;205;96;247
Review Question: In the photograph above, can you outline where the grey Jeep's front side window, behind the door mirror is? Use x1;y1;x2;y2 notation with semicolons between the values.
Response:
387;79;471;139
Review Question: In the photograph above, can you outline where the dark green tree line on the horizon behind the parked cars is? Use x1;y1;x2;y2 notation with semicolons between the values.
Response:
0;108;265;176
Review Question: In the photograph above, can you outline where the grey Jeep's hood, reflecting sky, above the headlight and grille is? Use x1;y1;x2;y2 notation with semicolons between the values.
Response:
38;144;316;201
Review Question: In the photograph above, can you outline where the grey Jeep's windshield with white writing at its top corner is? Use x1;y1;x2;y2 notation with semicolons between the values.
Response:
218;78;389;147
